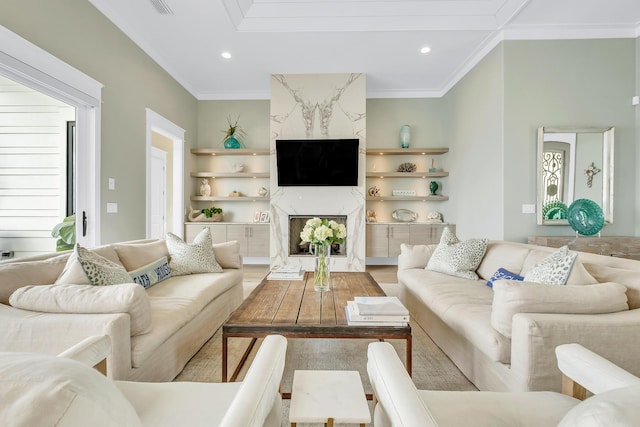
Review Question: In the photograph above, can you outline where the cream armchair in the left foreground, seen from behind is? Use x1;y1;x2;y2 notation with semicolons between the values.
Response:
0;335;287;427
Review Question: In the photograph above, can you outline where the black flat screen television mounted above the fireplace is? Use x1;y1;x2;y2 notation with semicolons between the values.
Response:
276;139;359;187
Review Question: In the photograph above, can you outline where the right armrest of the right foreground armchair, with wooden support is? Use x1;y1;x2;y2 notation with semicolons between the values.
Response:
556;343;640;399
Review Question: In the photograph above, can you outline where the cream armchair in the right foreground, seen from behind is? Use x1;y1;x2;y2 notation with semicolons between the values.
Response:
367;342;640;427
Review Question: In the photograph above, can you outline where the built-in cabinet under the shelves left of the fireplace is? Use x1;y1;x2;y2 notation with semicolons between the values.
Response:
184;222;269;257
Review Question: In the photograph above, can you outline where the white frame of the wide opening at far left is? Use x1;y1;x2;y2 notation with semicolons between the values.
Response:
0;25;103;247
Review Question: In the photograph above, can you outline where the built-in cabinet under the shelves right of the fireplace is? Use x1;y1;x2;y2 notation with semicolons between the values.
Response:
366;223;456;258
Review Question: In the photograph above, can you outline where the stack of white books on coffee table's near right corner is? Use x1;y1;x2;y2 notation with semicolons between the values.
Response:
345;297;409;326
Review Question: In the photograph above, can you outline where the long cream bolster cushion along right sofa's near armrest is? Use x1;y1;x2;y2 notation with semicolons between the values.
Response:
491;280;629;337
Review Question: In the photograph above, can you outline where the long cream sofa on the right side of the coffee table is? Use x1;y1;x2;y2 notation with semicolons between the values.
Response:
398;241;640;391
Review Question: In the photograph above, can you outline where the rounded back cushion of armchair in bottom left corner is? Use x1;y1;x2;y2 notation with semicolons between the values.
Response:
0;353;141;427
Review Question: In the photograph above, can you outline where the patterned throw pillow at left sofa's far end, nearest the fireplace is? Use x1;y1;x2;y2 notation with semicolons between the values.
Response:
167;227;222;276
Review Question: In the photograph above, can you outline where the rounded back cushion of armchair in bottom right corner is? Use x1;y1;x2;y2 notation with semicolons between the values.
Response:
558;386;640;427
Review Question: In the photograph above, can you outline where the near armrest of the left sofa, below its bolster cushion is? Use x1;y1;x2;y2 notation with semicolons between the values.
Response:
0;304;131;380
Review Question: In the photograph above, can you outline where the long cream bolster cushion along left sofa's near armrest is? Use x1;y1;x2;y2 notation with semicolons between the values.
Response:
9;283;151;336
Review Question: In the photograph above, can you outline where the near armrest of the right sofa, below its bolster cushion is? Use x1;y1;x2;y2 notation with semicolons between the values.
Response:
511;309;640;391
